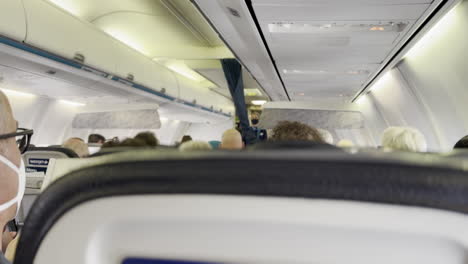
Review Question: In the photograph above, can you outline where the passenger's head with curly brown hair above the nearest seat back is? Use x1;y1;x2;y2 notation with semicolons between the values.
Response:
271;121;325;143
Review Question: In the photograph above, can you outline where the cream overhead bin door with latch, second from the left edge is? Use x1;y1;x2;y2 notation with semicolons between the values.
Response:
24;0;121;77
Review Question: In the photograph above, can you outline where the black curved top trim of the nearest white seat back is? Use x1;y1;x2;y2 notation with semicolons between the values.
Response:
15;150;468;264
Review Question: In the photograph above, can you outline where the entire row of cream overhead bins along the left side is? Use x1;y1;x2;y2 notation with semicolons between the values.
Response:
16;0;232;113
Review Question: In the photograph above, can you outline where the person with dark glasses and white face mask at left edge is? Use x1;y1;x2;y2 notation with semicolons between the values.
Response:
0;91;33;264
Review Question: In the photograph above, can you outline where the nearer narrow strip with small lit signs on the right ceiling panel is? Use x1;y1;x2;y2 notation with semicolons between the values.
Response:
268;22;408;34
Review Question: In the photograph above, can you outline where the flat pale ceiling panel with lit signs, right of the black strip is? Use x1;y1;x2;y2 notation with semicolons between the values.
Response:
252;0;432;101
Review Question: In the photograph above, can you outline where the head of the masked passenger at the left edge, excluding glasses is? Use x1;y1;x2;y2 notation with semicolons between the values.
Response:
0;91;25;232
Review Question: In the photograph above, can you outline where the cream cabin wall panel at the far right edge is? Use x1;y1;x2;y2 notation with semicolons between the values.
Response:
398;0;468;150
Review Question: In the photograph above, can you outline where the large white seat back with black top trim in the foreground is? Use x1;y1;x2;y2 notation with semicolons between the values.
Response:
15;150;468;264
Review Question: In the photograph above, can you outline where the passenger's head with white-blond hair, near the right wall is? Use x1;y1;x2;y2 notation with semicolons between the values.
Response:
382;127;427;152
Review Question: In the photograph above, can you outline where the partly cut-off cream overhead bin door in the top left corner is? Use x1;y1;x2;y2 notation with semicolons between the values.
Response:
0;0;26;41
